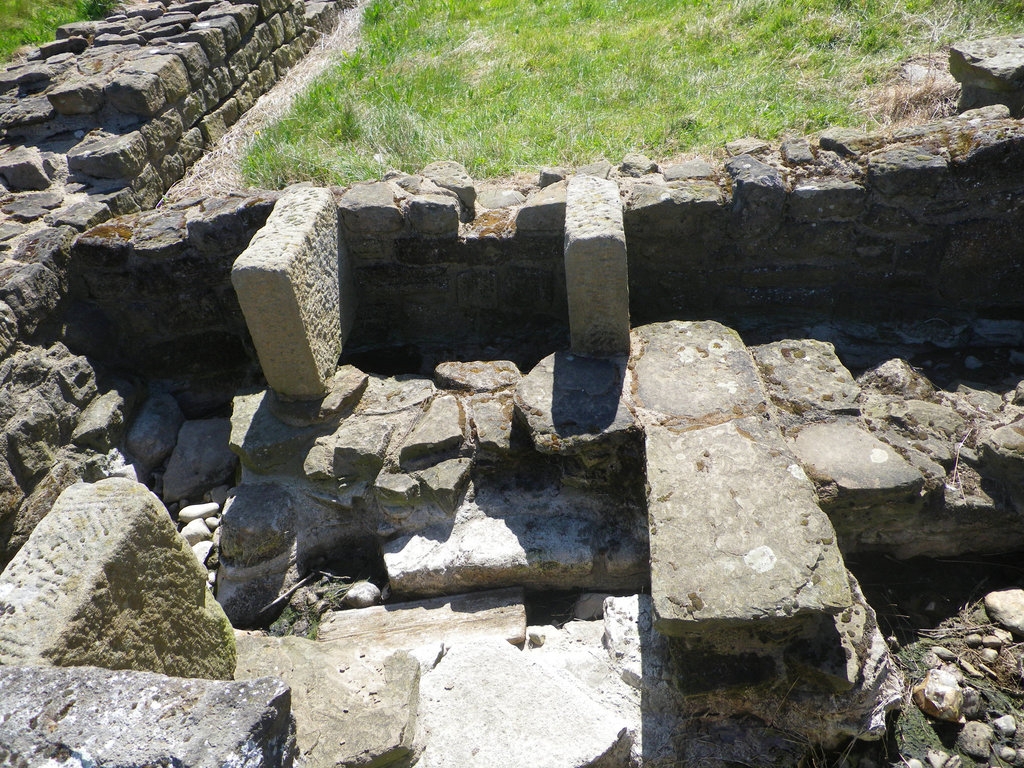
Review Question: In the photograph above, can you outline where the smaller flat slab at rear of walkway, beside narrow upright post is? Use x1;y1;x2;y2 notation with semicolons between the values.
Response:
631;321;767;427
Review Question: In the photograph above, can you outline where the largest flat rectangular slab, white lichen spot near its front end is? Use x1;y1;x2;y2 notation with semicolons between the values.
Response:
647;417;851;636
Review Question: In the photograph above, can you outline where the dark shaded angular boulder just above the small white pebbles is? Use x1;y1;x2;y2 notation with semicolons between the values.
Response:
164;419;238;502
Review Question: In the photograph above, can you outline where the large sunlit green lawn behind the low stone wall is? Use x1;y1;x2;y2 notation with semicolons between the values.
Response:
243;0;1024;186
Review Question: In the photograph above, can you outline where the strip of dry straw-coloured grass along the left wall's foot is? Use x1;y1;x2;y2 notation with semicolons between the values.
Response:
164;0;369;202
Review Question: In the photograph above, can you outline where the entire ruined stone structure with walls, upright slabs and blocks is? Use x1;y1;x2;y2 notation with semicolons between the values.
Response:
0;6;1024;768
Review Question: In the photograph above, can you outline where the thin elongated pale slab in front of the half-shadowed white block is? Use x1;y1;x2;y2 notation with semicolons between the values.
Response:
317;587;526;653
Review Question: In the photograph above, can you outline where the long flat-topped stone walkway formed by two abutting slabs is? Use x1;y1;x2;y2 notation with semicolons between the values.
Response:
632;322;852;652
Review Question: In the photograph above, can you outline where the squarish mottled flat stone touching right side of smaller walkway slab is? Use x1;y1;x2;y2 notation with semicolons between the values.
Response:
751;339;860;416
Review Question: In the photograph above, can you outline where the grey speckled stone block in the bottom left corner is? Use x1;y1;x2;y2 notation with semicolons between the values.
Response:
0;667;295;768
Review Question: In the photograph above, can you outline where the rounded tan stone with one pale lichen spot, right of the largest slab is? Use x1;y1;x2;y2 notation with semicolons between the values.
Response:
791;424;925;511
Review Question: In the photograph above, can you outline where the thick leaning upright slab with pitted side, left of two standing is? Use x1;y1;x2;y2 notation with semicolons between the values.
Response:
231;187;351;399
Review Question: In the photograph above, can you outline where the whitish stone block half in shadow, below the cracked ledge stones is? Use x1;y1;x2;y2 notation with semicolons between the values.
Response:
384;481;647;596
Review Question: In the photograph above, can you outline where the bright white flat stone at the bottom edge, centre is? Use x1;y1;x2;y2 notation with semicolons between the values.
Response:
418;641;630;768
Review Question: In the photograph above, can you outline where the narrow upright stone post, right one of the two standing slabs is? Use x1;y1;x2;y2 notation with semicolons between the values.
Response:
565;176;630;357
